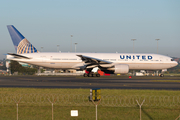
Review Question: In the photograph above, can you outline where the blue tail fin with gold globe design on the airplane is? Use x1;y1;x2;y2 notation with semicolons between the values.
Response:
7;25;38;54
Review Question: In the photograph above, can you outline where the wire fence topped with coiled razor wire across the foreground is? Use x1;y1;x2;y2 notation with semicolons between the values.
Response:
0;93;180;120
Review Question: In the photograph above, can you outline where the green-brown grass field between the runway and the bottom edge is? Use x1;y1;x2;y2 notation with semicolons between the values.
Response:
0;88;180;120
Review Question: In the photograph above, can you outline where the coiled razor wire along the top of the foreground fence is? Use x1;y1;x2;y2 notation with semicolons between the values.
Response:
0;93;180;108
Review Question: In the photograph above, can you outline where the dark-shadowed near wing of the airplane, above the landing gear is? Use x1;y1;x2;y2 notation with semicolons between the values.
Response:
77;55;112;65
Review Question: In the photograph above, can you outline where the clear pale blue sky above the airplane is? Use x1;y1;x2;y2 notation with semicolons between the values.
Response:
0;0;180;59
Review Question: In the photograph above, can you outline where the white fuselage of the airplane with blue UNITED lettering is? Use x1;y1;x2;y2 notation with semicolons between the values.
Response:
7;52;177;70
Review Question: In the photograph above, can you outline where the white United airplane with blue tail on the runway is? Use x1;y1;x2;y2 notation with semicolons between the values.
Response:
6;25;178;77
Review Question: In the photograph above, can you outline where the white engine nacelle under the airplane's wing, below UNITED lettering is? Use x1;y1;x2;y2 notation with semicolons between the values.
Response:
114;64;129;74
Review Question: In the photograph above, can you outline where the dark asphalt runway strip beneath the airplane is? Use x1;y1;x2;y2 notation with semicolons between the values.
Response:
0;76;180;90
